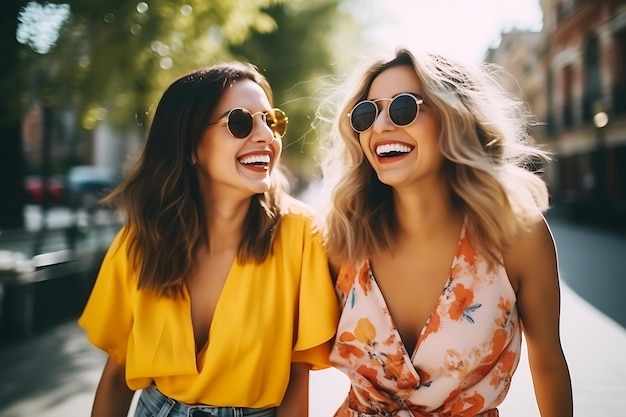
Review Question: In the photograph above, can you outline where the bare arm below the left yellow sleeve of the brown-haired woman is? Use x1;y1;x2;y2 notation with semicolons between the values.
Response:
91;357;135;417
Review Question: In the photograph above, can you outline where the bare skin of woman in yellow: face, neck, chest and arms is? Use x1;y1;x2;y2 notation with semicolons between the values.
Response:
92;80;309;417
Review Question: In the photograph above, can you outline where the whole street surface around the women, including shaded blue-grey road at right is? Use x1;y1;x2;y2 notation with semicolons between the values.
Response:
0;213;626;417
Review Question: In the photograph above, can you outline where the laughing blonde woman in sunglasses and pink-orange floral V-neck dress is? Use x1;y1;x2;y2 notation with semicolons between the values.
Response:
323;50;572;417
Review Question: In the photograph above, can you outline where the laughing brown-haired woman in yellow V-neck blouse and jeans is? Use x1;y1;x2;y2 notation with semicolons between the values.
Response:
79;62;337;417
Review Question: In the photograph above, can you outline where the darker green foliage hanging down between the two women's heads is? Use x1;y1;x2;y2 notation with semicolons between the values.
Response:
231;0;351;182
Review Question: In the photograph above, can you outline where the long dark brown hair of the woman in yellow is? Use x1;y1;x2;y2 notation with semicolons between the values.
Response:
103;62;288;297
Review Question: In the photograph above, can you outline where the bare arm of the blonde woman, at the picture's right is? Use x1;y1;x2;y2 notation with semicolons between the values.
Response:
505;219;573;417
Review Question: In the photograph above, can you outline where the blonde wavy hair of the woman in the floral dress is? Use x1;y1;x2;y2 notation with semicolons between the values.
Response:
321;49;549;266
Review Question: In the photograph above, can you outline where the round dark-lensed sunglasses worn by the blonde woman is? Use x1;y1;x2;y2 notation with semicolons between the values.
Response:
348;93;424;133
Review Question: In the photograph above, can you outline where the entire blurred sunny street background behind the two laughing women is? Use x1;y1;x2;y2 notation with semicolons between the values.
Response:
0;0;626;417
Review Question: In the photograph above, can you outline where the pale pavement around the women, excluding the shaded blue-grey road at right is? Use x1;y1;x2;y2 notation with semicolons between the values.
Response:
0;278;626;417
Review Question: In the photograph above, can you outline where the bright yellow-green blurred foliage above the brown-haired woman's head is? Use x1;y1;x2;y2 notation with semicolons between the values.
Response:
36;0;280;129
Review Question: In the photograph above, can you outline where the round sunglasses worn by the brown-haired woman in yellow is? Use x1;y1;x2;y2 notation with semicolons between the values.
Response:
208;107;289;139
